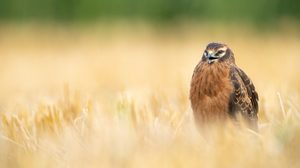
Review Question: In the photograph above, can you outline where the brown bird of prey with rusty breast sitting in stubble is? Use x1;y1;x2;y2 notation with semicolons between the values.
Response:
190;43;258;130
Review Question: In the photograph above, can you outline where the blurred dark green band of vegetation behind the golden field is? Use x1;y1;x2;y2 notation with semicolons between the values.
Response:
0;0;300;24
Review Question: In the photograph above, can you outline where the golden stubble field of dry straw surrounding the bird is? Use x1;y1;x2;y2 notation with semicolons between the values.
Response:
0;23;300;168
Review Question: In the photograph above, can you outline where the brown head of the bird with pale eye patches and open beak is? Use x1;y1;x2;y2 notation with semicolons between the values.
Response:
202;43;234;64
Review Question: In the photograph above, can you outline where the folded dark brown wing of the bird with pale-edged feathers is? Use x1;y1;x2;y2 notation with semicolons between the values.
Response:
229;66;258;130
